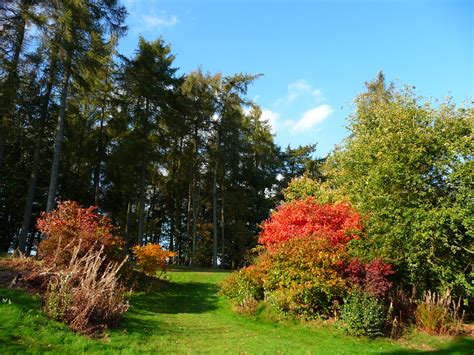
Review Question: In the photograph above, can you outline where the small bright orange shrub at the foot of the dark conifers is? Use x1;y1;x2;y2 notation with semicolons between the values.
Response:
132;244;176;276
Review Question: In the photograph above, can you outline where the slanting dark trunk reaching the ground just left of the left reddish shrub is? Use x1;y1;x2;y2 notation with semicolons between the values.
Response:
18;56;56;253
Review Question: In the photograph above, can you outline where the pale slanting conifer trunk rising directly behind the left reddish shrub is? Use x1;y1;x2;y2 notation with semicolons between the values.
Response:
46;55;72;212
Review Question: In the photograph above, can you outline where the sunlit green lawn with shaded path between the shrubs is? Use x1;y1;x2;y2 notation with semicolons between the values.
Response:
0;270;474;354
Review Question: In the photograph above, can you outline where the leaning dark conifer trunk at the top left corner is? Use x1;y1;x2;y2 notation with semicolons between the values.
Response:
0;0;30;172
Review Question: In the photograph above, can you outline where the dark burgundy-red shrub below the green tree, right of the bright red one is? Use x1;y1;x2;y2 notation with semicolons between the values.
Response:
345;258;395;298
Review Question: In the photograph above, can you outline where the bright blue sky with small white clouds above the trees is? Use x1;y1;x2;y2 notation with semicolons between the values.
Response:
119;0;474;156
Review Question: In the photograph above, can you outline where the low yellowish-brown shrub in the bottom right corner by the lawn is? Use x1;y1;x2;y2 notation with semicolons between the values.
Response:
415;290;464;335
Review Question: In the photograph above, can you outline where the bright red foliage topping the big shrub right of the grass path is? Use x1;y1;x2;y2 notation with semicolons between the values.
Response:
258;197;362;249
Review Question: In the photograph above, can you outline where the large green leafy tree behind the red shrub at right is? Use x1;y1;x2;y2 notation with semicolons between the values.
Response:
326;74;474;296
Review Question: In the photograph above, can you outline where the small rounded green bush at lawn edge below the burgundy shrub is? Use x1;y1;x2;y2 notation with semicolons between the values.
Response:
341;291;387;338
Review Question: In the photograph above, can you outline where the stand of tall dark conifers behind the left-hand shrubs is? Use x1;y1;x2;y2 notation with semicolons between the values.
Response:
0;0;288;267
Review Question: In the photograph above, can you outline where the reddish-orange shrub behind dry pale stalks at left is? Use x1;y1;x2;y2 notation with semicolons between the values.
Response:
37;201;123;266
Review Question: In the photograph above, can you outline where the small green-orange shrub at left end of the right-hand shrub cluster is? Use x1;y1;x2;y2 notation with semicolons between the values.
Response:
220;265;265;307
